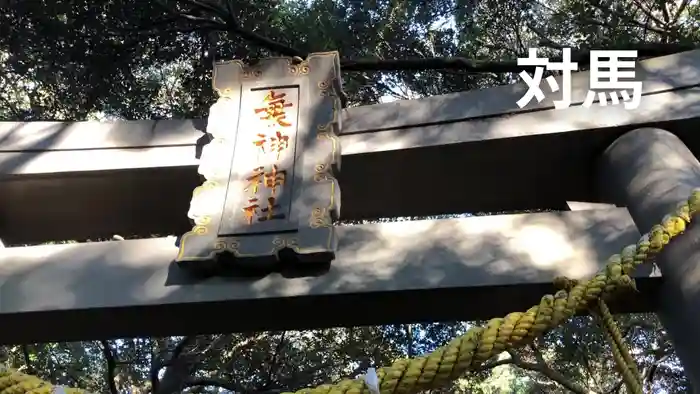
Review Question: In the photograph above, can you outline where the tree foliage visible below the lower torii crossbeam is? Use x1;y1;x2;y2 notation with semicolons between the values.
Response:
4;315;690;394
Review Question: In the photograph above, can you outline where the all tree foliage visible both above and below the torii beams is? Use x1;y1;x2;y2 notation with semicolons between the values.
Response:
0;0;700;394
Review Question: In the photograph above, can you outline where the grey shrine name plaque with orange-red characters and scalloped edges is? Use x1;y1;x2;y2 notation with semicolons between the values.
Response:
176;52;342;268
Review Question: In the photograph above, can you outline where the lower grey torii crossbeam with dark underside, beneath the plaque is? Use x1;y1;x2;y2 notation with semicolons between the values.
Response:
0;208;657;343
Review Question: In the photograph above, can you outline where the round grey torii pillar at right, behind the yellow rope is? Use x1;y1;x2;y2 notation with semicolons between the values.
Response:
597;128;700;392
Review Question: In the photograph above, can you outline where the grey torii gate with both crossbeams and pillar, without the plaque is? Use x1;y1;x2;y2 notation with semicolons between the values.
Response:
0;51;700;386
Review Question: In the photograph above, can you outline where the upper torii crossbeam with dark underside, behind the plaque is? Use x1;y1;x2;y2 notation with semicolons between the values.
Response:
0;51;700;245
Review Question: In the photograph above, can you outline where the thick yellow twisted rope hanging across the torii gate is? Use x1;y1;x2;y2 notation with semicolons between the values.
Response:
0;190;700;394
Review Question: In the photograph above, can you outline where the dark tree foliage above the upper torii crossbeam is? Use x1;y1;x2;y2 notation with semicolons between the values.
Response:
0;0;700;119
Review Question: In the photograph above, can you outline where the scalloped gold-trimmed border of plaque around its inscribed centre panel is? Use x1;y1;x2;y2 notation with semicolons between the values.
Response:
175;51;342;268
